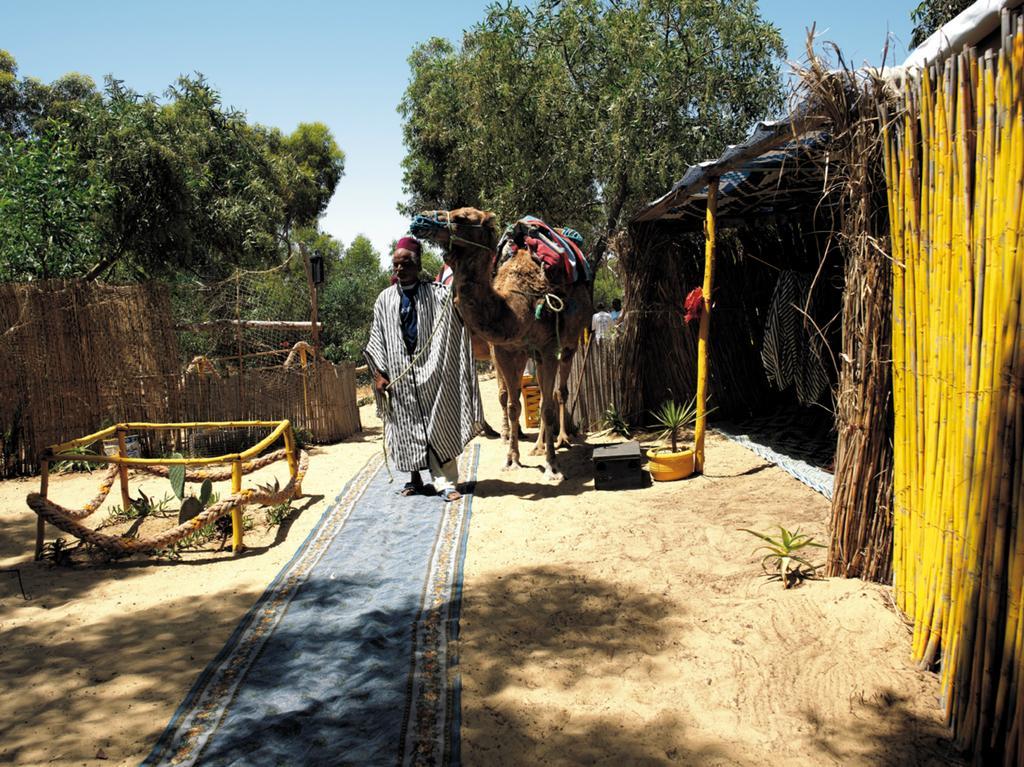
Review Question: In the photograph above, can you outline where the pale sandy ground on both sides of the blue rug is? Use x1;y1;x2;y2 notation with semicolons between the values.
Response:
0;374;958;765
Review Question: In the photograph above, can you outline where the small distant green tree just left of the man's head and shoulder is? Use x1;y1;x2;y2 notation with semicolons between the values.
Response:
319;235;390;361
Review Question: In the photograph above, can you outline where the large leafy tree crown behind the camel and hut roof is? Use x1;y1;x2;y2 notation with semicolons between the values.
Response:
398;0;783;249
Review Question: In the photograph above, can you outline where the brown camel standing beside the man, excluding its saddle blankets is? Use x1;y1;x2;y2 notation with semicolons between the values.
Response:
414;208;593;481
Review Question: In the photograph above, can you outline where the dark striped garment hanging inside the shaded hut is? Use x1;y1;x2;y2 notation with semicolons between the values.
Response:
761;269;828;404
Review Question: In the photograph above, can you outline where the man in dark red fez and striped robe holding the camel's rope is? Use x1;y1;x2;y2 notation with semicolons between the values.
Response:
365;237;483;501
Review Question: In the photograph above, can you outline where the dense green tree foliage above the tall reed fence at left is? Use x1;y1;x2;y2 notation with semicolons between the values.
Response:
0;51;344;280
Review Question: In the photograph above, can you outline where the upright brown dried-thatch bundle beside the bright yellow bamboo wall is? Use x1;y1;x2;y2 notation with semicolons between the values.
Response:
800;41;893;583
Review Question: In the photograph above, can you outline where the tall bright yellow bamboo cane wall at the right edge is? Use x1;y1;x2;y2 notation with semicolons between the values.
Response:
883;20;1024;765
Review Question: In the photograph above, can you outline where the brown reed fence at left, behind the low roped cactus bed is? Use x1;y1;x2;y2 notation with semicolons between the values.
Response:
0;282;360;477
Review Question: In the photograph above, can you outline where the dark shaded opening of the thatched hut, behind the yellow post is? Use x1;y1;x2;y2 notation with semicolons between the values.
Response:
624;118;844;497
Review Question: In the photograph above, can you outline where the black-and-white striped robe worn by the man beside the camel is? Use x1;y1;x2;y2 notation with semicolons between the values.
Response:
366;282;483;472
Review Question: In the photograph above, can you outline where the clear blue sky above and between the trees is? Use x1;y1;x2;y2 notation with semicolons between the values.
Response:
0;0;916;259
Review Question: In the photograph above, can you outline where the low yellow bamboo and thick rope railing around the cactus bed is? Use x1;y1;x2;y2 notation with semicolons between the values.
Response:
26;421;309;559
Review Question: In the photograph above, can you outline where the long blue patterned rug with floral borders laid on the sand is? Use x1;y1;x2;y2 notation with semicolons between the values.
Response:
142;445;479;766
